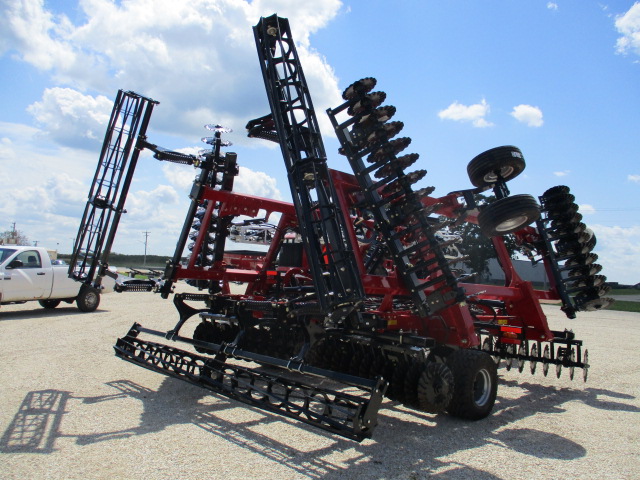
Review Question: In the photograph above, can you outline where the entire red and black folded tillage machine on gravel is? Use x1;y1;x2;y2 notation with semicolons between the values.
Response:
73;15;610;440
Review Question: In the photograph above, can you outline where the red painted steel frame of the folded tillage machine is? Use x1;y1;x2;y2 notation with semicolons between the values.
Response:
172;170;558;348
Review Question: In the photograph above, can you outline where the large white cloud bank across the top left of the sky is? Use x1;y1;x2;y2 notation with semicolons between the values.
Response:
0;0;341;144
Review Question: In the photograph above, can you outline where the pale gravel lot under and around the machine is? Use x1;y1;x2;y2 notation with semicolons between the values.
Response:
0;286;640;480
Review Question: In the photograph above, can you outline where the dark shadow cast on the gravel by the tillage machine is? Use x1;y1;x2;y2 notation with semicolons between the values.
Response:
0;378;640;480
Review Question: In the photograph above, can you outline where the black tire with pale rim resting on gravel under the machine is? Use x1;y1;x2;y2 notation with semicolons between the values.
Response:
447;349;498;420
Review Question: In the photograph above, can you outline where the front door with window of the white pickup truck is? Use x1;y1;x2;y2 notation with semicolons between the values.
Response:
2;250;53;302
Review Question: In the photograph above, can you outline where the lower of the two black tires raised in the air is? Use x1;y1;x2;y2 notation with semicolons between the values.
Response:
478;194;540;237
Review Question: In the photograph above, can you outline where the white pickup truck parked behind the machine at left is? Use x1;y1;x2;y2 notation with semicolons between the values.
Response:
0;245;115;312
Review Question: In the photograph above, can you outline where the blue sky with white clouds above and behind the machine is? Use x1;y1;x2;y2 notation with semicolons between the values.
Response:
0;0;640;283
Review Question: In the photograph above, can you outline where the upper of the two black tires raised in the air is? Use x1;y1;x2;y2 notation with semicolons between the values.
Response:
467;145;526;188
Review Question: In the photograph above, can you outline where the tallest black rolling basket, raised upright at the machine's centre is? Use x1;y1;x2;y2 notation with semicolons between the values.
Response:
253;15;364;316
